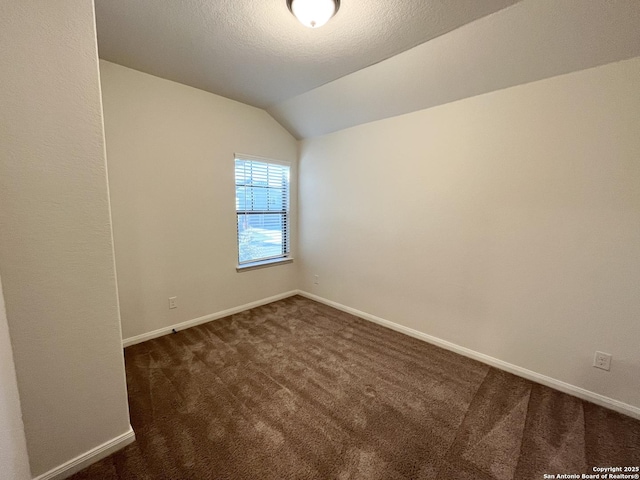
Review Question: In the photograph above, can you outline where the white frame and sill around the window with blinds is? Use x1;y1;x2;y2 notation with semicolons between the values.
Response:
233;153;293;272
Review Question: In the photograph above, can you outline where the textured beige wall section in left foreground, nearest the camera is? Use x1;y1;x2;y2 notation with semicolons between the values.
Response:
0;0;129;476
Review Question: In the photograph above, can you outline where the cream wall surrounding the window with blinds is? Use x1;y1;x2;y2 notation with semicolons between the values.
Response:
100;61;297;339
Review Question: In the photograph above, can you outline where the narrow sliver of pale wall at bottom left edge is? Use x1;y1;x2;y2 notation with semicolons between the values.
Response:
0;281;31;480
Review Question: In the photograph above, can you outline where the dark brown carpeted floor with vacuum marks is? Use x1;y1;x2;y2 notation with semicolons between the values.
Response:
72;296;640;480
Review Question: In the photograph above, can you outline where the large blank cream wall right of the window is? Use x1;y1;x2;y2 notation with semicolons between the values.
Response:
299;58;640;407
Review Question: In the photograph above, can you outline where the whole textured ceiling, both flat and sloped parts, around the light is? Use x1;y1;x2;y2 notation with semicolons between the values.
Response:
95;0;640;138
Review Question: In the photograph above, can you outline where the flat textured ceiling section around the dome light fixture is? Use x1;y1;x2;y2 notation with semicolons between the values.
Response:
95;0;517;108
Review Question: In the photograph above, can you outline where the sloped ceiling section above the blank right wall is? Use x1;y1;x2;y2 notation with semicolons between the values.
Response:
267;0;640;138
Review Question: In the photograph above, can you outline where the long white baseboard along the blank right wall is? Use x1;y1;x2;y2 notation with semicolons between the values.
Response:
297;290;640;419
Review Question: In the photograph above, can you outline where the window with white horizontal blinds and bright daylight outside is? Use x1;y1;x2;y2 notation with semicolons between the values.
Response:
235;155;290;268
